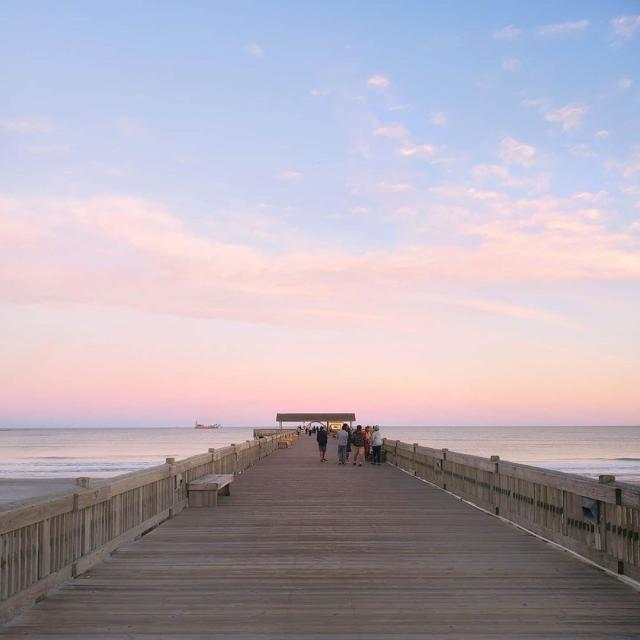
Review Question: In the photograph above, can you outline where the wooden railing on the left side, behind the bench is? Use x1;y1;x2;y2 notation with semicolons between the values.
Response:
0;433;294;621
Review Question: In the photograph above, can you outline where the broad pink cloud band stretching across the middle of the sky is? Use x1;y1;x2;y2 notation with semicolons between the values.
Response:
0;192;640;336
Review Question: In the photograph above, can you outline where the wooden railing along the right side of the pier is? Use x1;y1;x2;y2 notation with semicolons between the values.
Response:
383;440;640;580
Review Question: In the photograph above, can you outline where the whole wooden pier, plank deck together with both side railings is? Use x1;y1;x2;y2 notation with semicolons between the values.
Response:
0;430;640;640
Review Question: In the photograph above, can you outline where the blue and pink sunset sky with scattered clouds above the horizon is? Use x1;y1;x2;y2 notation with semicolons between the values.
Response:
0;0;640;427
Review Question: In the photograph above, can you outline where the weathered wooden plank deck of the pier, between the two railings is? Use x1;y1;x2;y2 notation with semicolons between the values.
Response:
0;436;640;640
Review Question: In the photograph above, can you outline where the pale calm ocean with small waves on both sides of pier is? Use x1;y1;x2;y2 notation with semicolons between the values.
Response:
0;426;640;482
